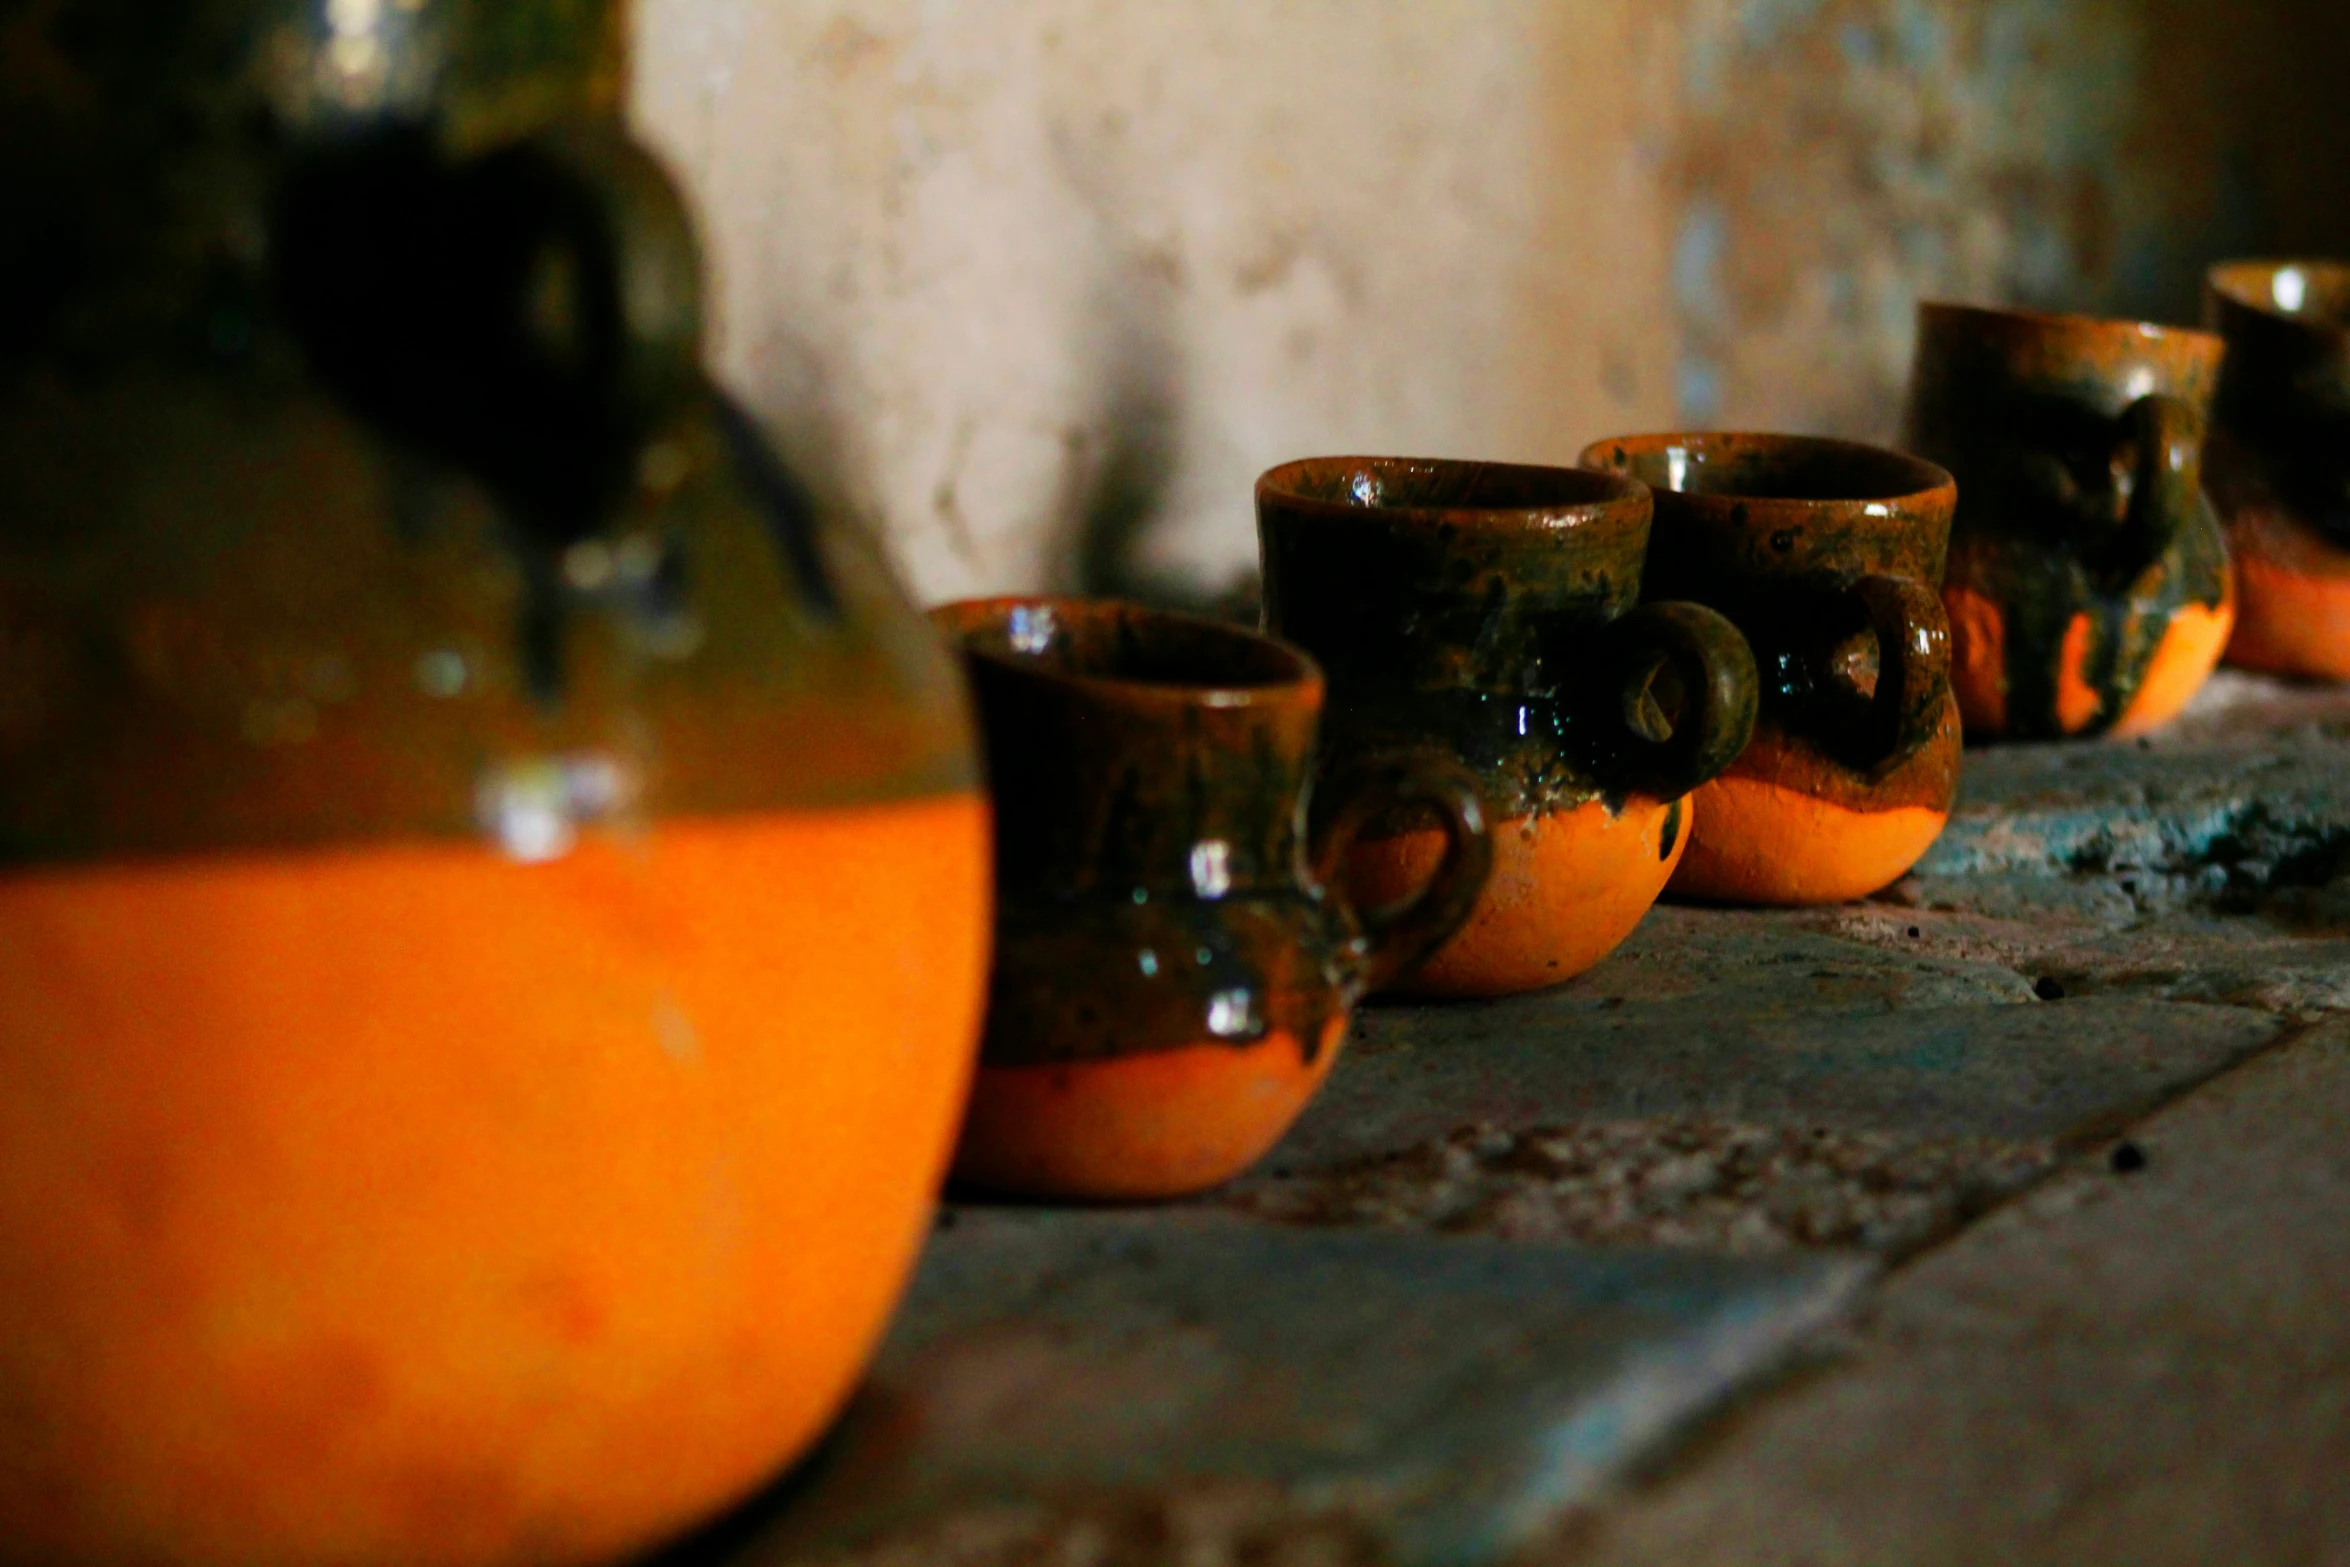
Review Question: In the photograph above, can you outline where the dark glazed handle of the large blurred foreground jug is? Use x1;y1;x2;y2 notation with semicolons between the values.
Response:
270;120;705;530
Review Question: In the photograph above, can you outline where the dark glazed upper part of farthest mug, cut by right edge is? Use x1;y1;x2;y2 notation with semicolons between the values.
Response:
2204;261;2350;550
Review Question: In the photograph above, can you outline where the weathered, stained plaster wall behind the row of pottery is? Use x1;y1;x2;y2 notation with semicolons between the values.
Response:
637;0;2350;599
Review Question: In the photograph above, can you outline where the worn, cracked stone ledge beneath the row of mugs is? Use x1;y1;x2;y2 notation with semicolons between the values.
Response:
670;677;2350;1567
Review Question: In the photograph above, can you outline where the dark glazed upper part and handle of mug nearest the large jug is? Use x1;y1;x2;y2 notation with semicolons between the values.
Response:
933;599;1490;1067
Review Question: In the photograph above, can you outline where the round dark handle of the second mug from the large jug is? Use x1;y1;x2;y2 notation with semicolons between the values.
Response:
1605;599;1760;799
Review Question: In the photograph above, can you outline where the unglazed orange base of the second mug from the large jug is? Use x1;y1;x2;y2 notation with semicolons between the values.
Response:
1347;785;1682;996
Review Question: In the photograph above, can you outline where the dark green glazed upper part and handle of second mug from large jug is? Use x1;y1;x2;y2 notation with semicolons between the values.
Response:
1257;458;1755;820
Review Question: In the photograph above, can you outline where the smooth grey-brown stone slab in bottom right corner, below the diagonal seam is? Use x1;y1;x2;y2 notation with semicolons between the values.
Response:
1525;1024;2350;1567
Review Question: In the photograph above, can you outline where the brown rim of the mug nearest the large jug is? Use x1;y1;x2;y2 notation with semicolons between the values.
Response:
931;594;1323;709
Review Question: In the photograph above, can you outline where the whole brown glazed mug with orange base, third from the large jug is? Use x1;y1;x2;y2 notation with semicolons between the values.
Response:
1584;435;1960;904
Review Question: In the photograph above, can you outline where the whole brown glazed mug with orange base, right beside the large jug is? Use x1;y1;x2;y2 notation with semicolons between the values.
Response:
933;599;1490;1198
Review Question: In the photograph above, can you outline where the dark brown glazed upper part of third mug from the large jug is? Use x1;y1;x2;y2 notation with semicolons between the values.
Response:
1582;432;1955;811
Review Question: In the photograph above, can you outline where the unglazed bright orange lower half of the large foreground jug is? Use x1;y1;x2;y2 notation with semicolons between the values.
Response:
0;796;987;1562
